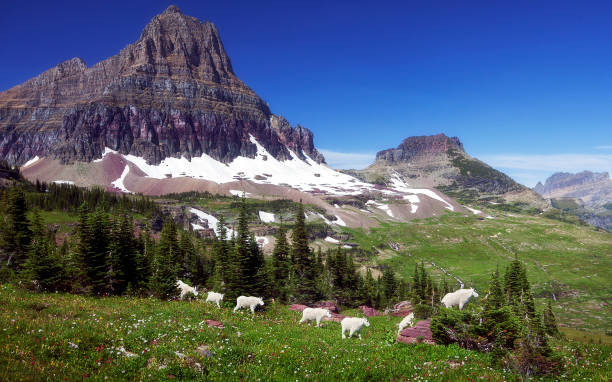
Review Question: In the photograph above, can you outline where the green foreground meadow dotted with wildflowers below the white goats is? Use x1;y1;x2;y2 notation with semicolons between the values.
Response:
0;285;612;381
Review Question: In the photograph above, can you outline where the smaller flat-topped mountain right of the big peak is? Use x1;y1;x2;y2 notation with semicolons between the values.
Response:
354;134;546;208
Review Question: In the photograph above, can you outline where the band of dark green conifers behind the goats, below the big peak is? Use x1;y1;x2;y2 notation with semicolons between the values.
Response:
0;183;437;308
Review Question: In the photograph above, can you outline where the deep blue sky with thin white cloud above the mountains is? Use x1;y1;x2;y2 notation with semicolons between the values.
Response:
0;0;612;186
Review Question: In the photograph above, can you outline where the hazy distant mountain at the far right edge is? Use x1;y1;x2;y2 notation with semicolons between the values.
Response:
533;171;612;231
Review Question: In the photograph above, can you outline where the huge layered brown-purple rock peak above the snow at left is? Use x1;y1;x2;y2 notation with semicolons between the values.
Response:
0;6;324;165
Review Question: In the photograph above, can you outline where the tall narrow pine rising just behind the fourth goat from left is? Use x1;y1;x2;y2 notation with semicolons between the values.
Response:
291;202;317;303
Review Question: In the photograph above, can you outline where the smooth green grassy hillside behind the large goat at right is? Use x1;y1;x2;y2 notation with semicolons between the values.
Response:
346;211;612;332
